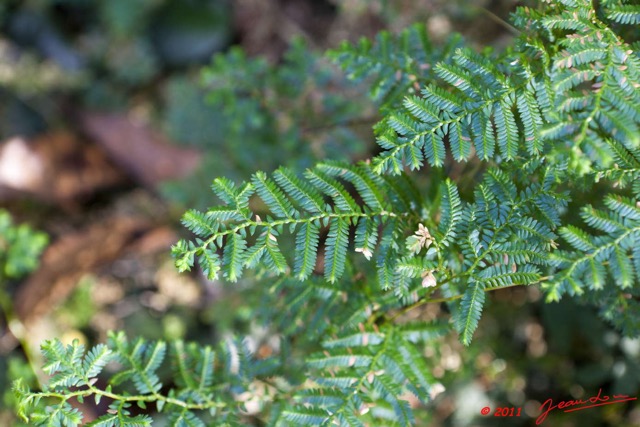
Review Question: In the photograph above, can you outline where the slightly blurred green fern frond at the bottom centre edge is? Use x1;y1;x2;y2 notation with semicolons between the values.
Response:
296;324;448;425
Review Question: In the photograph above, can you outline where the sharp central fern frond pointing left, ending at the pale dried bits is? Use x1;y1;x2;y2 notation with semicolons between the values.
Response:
173;162;418;290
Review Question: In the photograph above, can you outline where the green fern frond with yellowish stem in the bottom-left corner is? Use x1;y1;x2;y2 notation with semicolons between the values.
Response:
14;333;271;427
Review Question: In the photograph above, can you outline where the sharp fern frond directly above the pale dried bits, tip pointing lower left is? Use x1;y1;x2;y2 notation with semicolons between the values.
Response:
375;45;546;173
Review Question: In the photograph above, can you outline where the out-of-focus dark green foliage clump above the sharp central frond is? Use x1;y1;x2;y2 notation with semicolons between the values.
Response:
162;40;378;207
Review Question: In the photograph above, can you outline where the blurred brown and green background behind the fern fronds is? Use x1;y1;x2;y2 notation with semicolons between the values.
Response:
0;0;640;427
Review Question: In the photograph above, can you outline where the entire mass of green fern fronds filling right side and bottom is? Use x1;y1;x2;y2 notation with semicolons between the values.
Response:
17;0;640;426
